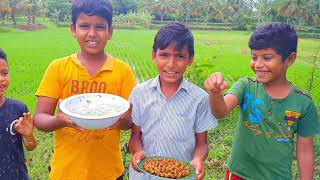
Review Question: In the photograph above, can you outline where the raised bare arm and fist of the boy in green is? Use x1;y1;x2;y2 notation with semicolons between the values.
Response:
204;72;238;119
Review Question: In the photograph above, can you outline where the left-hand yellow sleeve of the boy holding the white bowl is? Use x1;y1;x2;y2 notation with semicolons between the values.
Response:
35;61;61;99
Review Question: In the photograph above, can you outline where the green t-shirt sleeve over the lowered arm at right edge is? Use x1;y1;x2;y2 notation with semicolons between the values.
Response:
297;101;320;137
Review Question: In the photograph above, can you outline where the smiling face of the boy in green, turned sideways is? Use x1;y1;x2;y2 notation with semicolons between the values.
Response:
250;48;296;85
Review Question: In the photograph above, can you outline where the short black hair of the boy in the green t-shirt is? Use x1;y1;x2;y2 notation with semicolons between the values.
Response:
249;23;298;60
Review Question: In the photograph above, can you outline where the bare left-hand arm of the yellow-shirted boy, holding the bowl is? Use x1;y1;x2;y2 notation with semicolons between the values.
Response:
34;96;81;132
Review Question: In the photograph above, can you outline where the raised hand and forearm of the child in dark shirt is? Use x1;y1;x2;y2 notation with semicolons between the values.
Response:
14;112;37;151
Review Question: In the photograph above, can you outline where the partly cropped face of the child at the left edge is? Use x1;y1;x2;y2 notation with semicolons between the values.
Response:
0;58;10;98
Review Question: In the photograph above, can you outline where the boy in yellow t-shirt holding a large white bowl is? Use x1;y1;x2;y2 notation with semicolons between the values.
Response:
34;0;135;180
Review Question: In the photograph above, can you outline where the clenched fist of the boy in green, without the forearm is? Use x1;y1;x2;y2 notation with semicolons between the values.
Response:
204;72;228;93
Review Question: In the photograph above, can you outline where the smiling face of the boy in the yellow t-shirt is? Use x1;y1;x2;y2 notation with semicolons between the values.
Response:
71;13;113;55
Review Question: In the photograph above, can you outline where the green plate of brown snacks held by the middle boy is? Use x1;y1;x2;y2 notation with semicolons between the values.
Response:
138;157;197;180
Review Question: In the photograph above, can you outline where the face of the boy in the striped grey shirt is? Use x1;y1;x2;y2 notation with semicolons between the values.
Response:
152;43;193;86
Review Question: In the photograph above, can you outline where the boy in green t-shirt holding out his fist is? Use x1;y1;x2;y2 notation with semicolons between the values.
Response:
204;23;320;180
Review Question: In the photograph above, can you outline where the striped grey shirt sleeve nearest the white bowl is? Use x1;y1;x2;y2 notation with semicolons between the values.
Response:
129;87;141;126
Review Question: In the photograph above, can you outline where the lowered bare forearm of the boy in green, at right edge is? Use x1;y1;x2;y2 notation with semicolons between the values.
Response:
296;136;314;180
